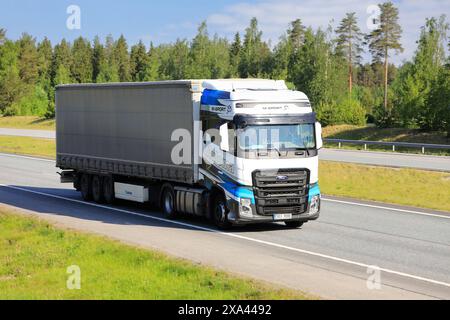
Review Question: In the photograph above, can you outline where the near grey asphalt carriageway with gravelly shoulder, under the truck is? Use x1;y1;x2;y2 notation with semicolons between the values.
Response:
0;154;450;299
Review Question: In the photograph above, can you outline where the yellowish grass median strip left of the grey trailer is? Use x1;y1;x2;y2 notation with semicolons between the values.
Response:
0;136;56;159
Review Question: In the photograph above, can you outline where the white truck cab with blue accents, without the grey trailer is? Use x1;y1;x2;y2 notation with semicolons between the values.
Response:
200;80;322;227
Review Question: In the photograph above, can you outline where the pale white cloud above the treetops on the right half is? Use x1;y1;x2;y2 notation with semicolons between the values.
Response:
207;0;450;63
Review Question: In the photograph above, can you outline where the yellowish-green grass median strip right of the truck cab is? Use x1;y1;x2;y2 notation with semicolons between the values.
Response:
320;161;450;212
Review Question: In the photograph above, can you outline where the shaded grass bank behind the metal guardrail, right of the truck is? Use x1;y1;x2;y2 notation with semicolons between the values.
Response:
323;125;450;156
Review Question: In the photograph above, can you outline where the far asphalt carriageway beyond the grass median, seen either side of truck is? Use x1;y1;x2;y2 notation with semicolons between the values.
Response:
0;128;450;172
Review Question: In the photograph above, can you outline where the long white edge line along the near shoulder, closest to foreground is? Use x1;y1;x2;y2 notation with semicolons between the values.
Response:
0;184;450;288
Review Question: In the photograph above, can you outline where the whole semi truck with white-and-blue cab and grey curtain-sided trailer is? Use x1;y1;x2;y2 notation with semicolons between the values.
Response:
56;79;322;229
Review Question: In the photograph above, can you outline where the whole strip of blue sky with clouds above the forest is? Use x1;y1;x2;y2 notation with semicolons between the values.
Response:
0;0;450;63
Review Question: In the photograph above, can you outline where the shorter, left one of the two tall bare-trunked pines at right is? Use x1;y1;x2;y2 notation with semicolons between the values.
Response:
335;12;363;96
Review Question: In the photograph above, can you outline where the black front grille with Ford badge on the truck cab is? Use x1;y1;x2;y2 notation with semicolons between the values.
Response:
253;169;309;216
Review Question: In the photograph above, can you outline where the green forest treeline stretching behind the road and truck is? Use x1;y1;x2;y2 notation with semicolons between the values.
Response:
0;2;450;134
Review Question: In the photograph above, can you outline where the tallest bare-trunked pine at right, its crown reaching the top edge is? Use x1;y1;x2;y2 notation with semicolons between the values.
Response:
368;2;403;112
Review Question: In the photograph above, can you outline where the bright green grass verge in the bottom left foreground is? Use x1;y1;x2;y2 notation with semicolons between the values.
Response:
0;207;307;300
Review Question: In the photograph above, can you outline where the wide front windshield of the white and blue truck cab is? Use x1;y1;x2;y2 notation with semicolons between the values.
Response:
238;124;316;151
